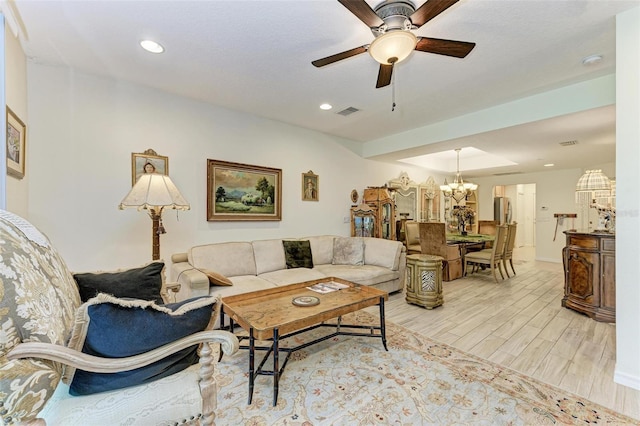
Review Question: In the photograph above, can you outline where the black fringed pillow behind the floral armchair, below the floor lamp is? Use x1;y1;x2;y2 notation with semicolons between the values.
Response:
73;261;164;303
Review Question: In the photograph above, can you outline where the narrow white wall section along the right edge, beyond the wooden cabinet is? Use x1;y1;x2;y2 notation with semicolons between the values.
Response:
614;7;640;389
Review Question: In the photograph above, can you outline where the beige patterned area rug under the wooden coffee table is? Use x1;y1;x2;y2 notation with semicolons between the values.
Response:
216;312;640;426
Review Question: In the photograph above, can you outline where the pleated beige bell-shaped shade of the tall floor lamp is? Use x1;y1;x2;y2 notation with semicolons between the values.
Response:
119;173;191;210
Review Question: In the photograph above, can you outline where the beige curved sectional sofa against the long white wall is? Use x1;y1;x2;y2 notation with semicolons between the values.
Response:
171;235;406;300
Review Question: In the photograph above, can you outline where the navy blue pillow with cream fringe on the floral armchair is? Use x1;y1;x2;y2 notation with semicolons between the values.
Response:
69;294;217;395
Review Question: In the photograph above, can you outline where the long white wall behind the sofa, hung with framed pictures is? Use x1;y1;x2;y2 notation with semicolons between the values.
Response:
28;63;427;271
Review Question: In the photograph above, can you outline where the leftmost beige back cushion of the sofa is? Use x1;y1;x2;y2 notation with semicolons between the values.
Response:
189;242;256;278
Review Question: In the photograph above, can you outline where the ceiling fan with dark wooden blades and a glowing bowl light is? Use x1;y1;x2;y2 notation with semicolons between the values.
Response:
311;0;476;88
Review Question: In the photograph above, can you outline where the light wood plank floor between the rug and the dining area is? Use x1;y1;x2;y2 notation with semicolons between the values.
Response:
376;248;640;419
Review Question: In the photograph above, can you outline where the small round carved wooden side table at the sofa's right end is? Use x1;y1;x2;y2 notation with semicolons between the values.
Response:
405;254;444;309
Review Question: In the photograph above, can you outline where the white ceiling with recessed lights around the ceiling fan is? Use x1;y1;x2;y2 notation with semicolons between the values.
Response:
1;0;640;176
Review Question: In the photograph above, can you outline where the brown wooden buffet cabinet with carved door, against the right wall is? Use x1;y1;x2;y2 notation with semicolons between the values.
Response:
562;231;616;322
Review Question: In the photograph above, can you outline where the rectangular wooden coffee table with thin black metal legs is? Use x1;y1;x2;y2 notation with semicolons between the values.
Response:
220;277;389;406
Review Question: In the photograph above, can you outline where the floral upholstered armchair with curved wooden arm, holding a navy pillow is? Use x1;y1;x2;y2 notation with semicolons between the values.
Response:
0;210;238;426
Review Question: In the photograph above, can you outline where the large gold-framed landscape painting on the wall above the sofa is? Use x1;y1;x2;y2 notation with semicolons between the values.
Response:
207;159;282;221
